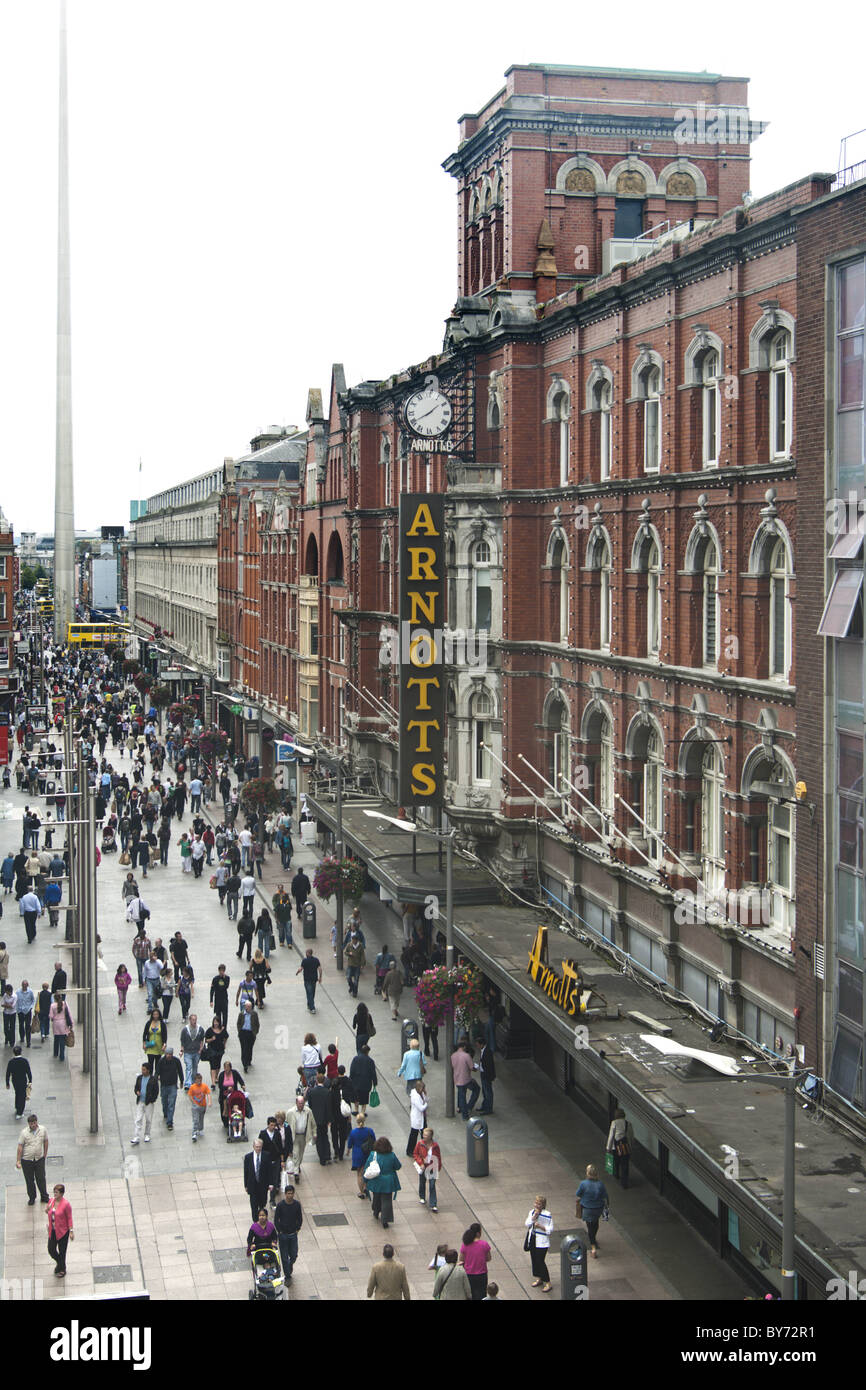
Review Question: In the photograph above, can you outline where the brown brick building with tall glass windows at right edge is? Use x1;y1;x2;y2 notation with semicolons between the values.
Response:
796;182;866;1116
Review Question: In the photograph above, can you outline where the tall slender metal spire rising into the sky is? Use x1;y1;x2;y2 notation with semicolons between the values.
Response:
54;0;75;642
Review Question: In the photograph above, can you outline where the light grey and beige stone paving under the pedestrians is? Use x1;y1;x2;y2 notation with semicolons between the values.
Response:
0;745;742;1301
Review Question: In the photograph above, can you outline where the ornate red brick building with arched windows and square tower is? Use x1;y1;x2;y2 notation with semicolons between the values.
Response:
214;65;862;1090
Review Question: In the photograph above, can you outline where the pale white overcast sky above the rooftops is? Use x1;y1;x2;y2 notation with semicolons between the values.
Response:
0;0;866;531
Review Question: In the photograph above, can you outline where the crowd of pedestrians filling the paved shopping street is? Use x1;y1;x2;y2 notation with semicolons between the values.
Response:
0;625;628;1300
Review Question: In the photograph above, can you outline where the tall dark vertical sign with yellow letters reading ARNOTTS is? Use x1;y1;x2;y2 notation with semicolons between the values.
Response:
399;492;445;806
